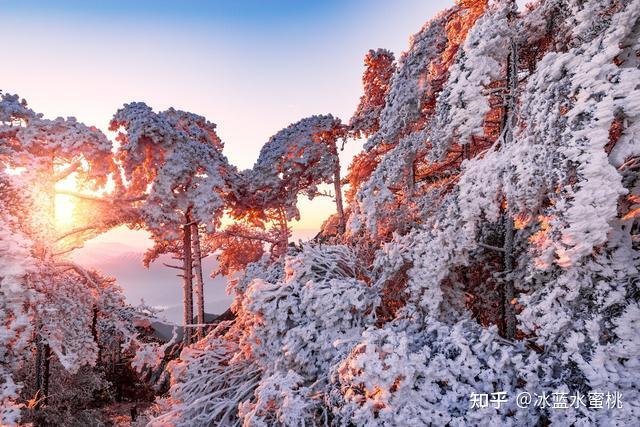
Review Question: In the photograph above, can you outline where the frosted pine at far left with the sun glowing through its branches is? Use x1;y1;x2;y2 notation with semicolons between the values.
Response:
0;95;152;424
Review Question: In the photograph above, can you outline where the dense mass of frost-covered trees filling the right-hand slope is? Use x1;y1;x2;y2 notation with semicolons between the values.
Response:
154;0;640;426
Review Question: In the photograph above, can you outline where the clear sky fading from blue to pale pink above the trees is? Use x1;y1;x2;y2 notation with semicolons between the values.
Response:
0;0;460;320
